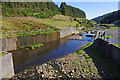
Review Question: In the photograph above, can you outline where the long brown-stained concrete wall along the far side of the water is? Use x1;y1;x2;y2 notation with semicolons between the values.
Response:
0;32;60;51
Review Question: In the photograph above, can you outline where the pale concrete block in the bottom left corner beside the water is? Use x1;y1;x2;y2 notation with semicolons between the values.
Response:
0;53;14;78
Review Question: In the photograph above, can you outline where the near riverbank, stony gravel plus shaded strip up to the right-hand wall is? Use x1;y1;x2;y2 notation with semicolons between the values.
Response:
11;40;119;79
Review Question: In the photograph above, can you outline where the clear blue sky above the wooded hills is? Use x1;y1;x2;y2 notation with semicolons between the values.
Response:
54;2;118;19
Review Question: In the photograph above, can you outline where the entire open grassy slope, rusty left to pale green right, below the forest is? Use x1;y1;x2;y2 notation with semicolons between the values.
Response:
2;15;78;32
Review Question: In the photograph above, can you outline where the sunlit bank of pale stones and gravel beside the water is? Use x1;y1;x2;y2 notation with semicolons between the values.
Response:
11;53;101;79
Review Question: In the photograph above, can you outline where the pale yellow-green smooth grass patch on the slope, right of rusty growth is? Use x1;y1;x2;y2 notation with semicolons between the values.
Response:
29;15;77;29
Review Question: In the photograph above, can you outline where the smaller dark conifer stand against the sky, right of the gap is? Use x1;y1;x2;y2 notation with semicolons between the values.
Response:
60;3;86;18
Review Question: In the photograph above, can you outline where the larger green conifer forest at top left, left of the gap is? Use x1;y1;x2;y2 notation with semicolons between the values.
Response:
2;2;60;18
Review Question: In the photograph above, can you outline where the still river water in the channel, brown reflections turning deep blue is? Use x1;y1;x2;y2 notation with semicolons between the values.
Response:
12;34;94;73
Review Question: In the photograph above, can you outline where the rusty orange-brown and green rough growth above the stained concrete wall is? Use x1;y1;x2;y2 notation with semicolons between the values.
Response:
2;17;59;37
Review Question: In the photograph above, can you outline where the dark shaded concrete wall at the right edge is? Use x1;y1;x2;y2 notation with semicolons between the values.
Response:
95;39;120;64
